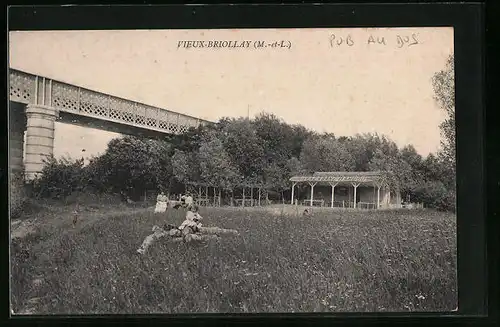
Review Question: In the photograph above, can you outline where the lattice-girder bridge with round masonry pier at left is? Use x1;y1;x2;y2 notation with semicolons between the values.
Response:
9;69;212;182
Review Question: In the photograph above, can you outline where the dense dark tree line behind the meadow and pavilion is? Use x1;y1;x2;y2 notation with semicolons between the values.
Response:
29;53;455;210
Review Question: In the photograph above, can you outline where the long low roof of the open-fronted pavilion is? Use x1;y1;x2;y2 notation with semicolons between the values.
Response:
290;171;386;184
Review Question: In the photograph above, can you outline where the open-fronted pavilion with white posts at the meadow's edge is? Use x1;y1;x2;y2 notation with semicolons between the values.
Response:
290;171;401;209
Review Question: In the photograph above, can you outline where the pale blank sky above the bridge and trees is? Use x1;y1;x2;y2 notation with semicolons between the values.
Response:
9;28;453;160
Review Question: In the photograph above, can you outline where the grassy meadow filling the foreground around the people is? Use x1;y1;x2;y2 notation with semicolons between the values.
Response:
11;202;457;314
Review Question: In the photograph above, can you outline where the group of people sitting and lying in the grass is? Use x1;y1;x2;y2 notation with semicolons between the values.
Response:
137;192;238;254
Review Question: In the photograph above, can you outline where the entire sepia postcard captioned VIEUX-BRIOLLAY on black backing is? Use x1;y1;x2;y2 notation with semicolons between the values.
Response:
8;27;458;315
